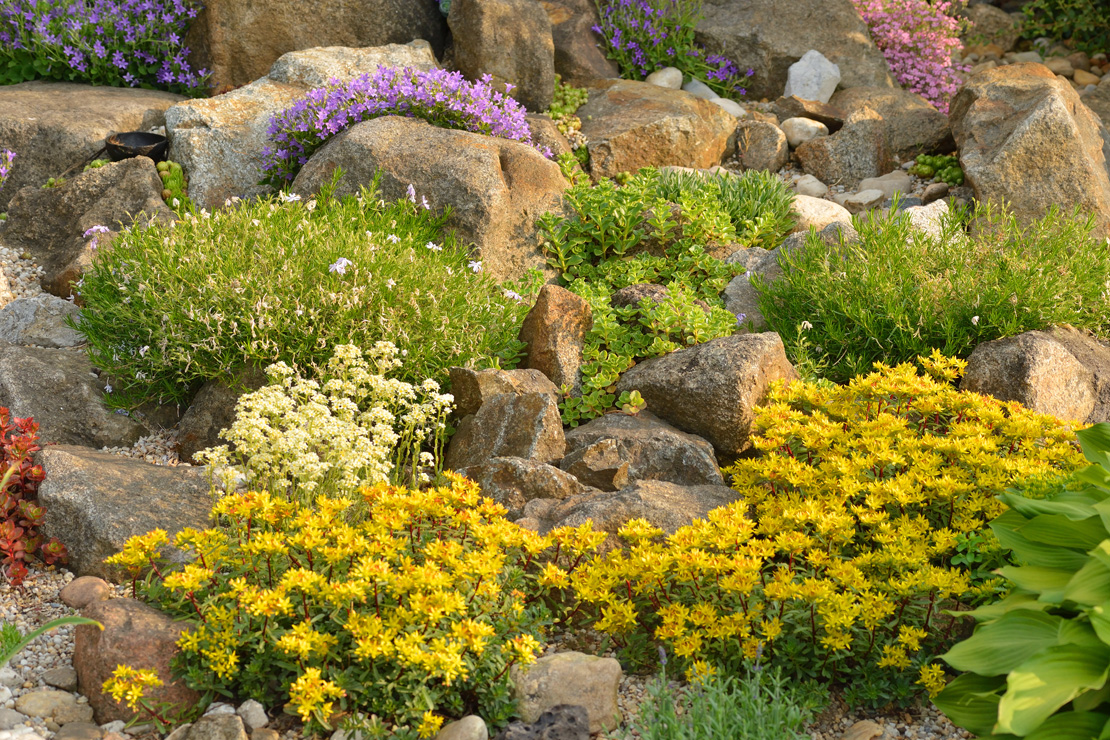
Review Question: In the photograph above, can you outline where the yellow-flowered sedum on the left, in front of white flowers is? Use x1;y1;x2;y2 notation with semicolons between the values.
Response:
109;475;604;740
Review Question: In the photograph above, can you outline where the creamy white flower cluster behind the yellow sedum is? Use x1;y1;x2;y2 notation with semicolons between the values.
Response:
199;342;454;498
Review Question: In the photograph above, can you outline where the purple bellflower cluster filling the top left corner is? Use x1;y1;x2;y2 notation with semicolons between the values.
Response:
0;0;208;95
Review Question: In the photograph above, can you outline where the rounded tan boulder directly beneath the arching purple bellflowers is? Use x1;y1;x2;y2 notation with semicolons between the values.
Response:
293;115;567;280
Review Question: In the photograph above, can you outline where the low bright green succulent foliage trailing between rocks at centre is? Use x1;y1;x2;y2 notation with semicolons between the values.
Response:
539;169;794;426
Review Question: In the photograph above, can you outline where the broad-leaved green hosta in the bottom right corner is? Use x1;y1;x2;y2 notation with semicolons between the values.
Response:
935;424;1110;739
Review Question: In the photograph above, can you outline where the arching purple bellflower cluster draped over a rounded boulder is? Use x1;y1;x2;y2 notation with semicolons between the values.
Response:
262;67;551;187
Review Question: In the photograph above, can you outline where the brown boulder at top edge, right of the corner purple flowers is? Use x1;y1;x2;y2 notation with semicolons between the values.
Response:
185;0;447;89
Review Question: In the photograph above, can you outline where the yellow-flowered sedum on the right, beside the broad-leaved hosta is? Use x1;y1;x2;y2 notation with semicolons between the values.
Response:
566;356;1081;707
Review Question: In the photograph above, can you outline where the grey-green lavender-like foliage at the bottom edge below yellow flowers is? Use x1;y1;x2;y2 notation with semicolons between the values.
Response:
633;668;817;740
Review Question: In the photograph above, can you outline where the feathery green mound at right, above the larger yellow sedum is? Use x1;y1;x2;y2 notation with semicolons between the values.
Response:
753;204;1110;383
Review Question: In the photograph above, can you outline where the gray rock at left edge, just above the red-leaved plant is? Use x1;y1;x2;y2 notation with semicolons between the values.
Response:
0;345;144;447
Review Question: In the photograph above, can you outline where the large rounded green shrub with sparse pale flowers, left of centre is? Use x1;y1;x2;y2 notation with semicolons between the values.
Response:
75;174;527;405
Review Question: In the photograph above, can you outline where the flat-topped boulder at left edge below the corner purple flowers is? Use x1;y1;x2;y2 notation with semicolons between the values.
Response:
0;82;184;211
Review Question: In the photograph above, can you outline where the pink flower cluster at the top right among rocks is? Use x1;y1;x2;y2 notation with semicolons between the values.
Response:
852;0;968;113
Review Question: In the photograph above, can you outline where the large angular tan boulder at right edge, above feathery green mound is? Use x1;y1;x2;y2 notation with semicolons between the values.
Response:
949;63;1110;236
